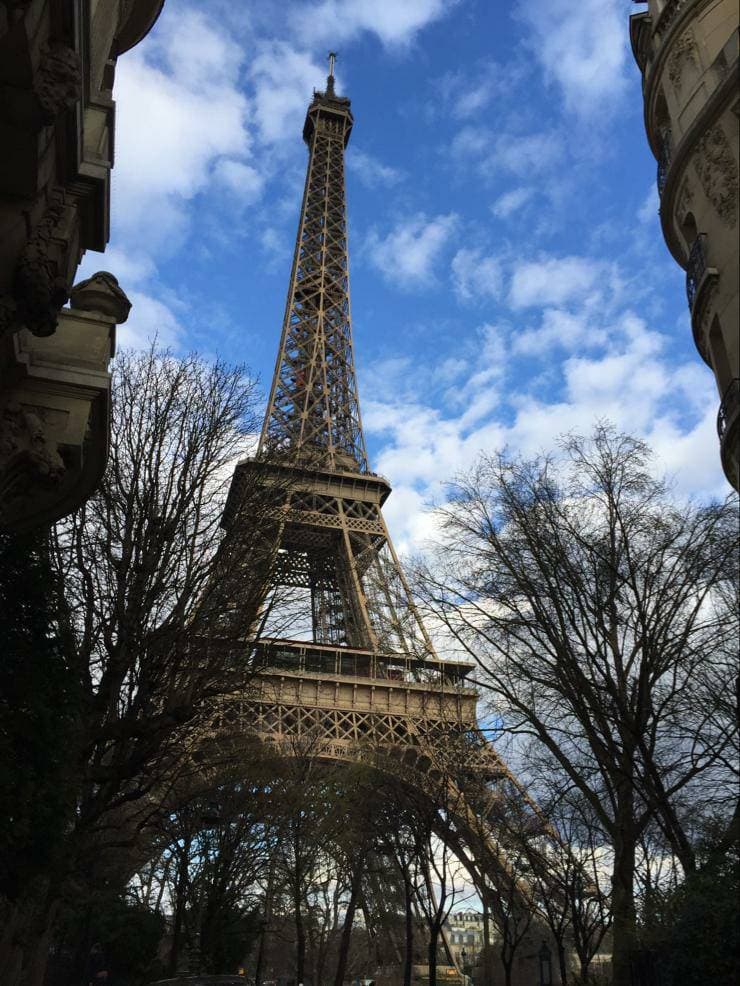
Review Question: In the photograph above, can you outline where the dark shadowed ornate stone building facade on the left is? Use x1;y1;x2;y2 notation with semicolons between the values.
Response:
0;0;164;531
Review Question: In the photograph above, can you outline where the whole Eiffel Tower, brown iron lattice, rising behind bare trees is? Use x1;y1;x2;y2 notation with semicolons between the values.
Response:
221;55;551;980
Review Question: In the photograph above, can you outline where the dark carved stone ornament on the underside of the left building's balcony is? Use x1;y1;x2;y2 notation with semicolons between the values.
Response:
0;401;65;522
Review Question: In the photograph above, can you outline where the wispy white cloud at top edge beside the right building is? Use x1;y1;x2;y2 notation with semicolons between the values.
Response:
518;0;628;120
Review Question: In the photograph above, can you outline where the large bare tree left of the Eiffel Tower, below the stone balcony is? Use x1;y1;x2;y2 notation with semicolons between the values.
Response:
0;348;284;986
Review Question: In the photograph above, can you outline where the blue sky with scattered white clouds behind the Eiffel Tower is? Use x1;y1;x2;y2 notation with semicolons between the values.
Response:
81;0;727;550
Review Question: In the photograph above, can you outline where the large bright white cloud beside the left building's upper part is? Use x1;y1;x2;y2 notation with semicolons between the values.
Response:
112;10;250;251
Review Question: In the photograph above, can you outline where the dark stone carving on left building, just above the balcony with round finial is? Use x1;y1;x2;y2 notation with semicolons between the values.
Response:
13;188;72;336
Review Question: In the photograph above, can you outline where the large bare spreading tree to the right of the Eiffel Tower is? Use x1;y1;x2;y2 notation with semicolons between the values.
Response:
421;425;738;986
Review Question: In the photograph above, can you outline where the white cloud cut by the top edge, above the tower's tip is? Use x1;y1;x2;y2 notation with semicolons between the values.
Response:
288;0;455;47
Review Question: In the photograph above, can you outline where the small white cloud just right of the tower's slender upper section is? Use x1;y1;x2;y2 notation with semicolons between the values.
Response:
367;213;458;287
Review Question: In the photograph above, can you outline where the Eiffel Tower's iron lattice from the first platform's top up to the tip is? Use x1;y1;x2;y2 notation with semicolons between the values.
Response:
226;67;434;657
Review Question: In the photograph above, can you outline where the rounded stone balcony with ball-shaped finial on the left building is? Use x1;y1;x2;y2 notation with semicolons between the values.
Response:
0;274;130;533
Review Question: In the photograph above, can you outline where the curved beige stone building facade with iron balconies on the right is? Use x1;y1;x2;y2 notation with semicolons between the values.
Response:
630;0;740;489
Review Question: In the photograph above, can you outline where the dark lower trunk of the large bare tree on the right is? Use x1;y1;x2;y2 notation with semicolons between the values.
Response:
612;812;637;986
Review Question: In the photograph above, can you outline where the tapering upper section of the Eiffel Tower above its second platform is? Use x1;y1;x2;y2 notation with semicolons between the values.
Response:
260;52;368;472
